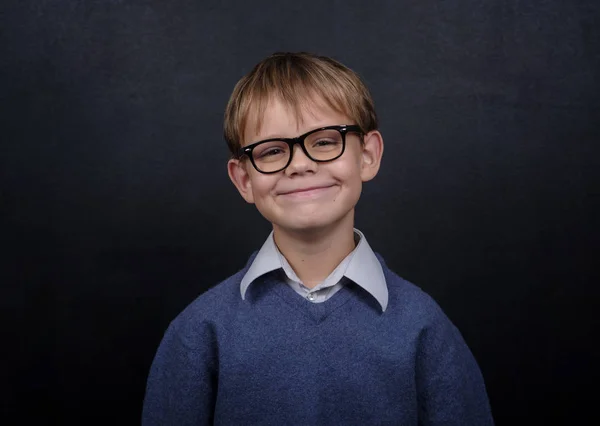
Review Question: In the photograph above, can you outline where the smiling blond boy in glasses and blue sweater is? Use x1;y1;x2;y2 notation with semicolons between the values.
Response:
142;53;493;426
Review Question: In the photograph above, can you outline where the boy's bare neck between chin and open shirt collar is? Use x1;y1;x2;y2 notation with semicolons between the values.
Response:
273;214;355;288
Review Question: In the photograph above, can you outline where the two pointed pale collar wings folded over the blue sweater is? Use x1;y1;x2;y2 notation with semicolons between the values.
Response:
240;229;388;312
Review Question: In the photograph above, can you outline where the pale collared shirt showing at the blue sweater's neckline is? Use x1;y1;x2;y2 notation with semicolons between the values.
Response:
240;229;388;312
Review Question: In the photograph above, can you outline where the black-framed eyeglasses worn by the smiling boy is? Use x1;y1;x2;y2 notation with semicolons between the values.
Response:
237;124;363;174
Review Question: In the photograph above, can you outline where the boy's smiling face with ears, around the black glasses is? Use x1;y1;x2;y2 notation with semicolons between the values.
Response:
228;99;383;232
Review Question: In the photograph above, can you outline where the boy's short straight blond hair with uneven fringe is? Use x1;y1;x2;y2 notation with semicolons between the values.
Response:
224;52;377;155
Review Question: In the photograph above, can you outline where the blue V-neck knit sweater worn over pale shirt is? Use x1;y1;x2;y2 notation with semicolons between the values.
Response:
142;256;493;426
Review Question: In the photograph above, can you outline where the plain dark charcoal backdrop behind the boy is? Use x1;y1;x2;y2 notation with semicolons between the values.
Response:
0;0;600;425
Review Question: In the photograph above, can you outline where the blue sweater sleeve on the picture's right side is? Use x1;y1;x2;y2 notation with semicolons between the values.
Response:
416;305;494;426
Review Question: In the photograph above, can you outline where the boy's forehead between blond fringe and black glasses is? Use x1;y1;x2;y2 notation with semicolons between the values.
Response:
243;96;350;146
